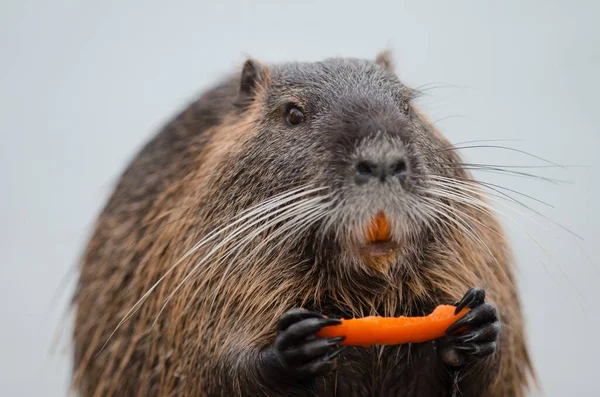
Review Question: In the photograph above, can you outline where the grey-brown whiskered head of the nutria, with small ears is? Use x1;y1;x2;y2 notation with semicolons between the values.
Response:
204;54;466;278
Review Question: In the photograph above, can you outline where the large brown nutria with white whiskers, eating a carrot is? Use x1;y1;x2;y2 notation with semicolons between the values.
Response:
74;52;533;397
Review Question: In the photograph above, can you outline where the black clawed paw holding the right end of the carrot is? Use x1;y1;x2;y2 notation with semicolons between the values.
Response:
437;288;501;367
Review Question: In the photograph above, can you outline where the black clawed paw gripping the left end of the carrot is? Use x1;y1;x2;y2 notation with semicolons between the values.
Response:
274;309;344;378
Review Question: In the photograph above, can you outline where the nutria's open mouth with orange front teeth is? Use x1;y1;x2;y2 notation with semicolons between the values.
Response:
359;211;400;271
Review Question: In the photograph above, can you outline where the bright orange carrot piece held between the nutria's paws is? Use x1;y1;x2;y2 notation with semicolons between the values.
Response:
317;305;469;346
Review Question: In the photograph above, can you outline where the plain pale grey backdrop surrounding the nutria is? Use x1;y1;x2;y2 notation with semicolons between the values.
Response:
0;0;600;396
